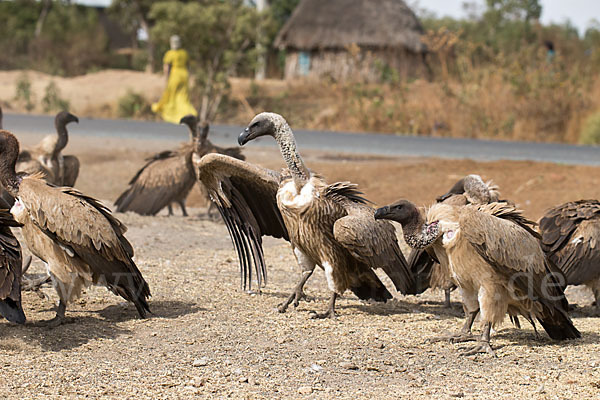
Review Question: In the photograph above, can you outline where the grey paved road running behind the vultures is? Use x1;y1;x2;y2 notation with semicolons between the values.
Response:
4;114;600;165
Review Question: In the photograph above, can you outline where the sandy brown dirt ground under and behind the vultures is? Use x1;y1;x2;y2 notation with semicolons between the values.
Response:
0;132;600;399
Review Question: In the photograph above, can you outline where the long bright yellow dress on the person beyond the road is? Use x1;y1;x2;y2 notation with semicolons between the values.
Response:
152;49;198;124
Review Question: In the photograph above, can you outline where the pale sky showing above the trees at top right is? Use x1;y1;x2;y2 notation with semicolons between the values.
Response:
408;0;600;34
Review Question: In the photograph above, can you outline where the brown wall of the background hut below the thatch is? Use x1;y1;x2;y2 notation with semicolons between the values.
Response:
284;50;426;82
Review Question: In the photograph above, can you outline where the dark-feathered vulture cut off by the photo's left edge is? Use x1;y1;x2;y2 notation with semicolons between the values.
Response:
0;199;25;324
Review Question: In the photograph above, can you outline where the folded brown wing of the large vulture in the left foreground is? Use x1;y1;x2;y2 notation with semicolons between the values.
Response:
18;178;150;317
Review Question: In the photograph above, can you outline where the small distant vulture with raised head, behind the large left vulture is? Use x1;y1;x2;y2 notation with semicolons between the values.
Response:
16;111;79;187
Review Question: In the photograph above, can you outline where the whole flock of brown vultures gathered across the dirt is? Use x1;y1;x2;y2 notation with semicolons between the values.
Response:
0;107;600;354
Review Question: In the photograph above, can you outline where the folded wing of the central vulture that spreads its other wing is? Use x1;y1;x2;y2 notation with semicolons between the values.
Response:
333;204;413;294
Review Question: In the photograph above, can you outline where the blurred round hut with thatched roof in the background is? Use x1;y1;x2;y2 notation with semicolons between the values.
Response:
275;0;426;81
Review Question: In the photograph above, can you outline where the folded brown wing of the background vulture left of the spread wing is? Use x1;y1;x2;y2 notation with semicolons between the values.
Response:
115;151;194;215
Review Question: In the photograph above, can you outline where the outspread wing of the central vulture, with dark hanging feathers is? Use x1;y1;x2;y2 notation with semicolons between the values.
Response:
194;153;290;289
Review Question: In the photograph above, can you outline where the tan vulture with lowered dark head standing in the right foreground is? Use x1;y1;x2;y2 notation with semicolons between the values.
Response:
375;200;581;355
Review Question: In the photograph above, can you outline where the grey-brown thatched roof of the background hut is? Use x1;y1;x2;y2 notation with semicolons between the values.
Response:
275;0;425;52
